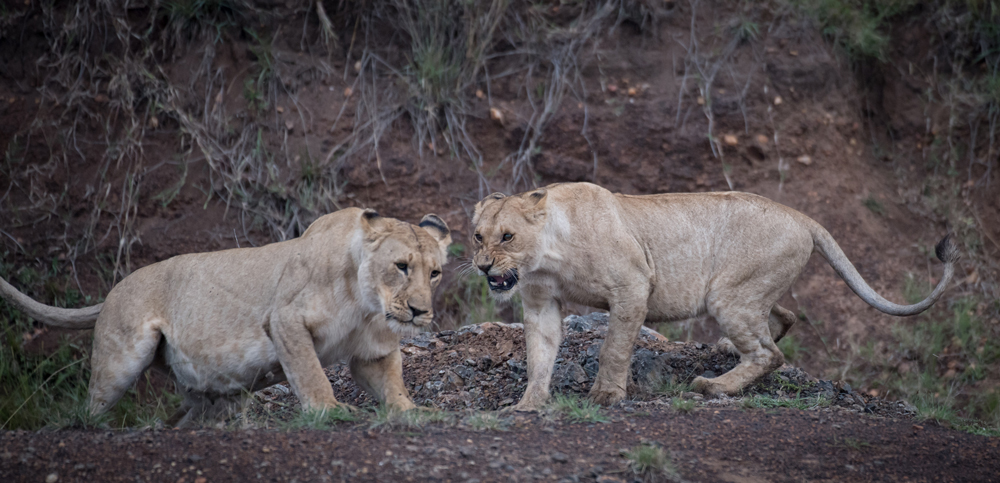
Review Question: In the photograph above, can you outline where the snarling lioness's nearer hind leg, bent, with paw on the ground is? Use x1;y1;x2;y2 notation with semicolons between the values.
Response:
692;307;785;396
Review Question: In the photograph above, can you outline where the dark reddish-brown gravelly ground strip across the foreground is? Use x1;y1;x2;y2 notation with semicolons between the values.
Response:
0;407;1000;483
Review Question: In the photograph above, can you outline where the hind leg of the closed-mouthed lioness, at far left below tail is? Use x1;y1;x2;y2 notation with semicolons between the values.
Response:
87;322;161;416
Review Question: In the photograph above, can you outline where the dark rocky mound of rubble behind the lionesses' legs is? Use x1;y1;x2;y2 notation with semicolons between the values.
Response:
255;313;913;417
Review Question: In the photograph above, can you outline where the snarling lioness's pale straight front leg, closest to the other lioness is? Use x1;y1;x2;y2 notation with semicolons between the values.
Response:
512;293;562;411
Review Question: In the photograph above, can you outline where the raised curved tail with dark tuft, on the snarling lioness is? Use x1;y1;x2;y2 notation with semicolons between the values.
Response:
809;220;960;315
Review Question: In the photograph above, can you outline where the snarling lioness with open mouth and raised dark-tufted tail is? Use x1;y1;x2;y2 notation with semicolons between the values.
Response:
472;183;958;410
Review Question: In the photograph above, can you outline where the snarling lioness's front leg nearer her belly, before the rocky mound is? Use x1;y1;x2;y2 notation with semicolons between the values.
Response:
588;300;647;406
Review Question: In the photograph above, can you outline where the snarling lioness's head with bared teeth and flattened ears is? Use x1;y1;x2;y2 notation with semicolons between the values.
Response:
472;189;547;300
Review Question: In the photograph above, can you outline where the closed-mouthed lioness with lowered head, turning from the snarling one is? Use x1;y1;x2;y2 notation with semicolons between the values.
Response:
0;208;451;426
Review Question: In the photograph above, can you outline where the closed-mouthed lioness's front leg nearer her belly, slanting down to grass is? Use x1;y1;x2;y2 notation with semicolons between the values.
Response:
270;317;340;410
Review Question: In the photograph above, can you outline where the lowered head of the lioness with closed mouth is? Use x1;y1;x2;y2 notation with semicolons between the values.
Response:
359;210;451;335
